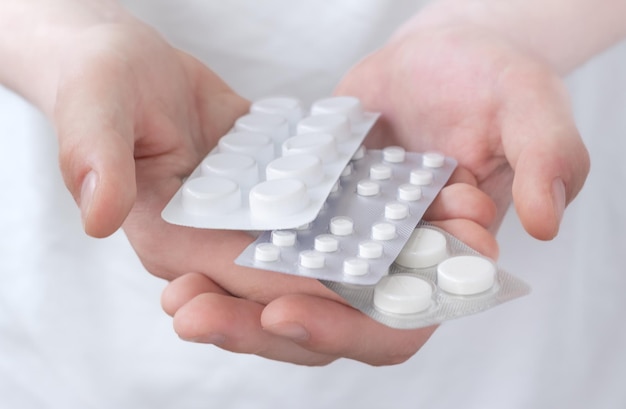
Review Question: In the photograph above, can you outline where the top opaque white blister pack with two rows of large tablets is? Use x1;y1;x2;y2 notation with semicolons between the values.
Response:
162;96;379;230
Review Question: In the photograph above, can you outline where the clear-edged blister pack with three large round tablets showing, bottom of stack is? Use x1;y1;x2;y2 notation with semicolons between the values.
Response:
322;222;530;329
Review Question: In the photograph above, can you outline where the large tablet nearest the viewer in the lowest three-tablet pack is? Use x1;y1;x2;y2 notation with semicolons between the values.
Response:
374;274;433;314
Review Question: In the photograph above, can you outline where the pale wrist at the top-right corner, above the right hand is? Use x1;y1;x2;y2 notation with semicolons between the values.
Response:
394;0;626;75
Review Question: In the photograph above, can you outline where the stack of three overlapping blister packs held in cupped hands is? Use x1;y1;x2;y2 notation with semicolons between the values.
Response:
162;96;529;328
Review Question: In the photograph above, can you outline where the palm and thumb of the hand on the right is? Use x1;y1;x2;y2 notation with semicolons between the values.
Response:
338;22;589;239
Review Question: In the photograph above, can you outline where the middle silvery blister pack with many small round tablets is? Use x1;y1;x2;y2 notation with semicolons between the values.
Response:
235;146;456;285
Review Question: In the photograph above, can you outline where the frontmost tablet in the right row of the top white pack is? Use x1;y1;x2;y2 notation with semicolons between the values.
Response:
249;179;309;220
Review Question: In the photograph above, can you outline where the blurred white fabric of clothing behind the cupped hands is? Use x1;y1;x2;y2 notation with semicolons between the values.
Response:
0;0;626;409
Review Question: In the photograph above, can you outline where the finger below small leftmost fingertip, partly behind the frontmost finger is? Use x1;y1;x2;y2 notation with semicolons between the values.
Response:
174;293;336;365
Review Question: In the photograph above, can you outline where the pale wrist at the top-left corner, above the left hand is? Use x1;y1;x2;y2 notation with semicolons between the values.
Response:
0;0;132;116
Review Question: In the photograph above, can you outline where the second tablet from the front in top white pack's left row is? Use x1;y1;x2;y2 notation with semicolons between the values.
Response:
200;153;259;188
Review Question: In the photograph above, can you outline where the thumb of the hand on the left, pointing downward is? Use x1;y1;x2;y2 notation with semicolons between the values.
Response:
54;77;136;237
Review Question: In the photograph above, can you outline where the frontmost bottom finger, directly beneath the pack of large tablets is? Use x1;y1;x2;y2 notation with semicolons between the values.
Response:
261;294;435;366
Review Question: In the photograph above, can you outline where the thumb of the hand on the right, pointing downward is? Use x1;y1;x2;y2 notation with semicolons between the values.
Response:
494;61;589;240
